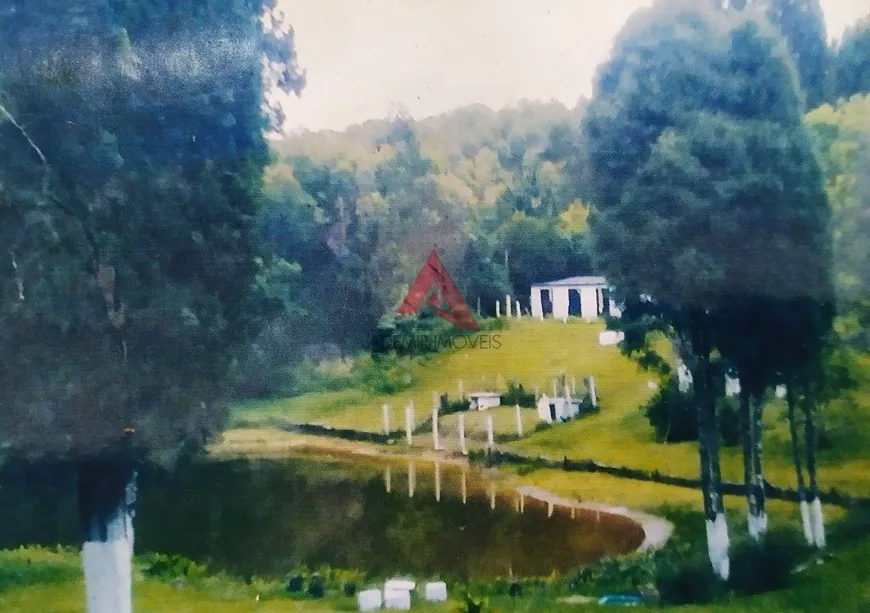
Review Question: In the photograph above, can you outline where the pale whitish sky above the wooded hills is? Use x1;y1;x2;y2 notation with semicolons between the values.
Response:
282;0;870;130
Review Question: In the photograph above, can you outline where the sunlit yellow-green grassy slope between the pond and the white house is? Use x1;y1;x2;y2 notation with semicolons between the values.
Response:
234;319;870;496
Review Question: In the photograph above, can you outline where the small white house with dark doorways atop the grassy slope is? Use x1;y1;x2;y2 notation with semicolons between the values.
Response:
530;277;619;319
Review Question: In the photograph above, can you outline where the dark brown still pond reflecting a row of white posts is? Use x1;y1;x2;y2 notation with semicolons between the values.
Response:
0;456;643;579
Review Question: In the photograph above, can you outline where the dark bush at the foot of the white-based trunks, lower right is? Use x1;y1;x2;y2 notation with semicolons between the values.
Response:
729;529;811;595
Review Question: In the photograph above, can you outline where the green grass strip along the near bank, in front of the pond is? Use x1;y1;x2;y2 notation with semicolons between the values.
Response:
0;538;870;613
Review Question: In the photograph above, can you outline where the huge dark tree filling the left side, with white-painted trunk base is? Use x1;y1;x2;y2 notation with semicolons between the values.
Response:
0;0;303;613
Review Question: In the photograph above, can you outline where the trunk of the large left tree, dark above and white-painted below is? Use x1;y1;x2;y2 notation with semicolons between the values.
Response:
78;456;136;613
